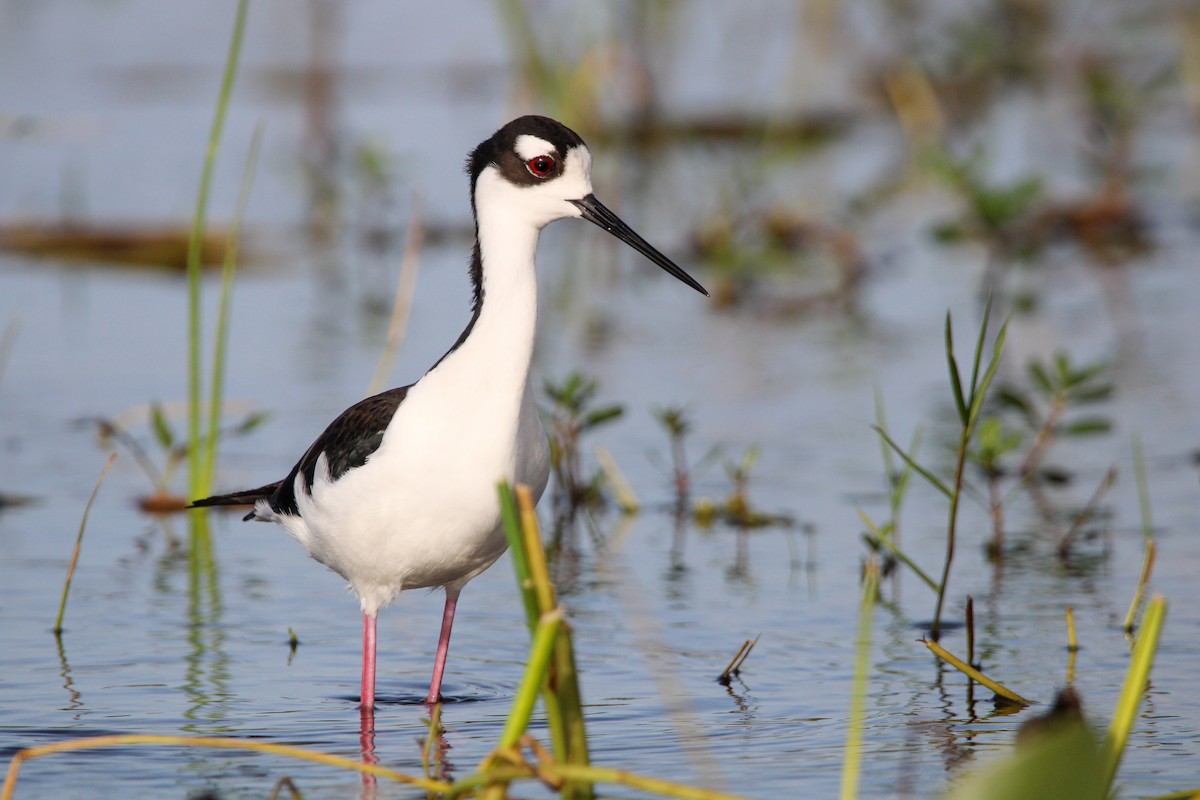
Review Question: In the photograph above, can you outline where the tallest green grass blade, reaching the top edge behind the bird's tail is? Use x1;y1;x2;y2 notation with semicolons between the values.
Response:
187;0;250;500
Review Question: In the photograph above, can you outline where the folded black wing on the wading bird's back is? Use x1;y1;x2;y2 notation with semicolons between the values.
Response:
270;386;410;513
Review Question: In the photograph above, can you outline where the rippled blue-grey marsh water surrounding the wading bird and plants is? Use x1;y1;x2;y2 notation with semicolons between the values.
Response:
0;0;1200;798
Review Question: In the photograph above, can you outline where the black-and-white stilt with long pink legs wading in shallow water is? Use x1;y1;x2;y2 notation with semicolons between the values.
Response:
193;116;708;709
